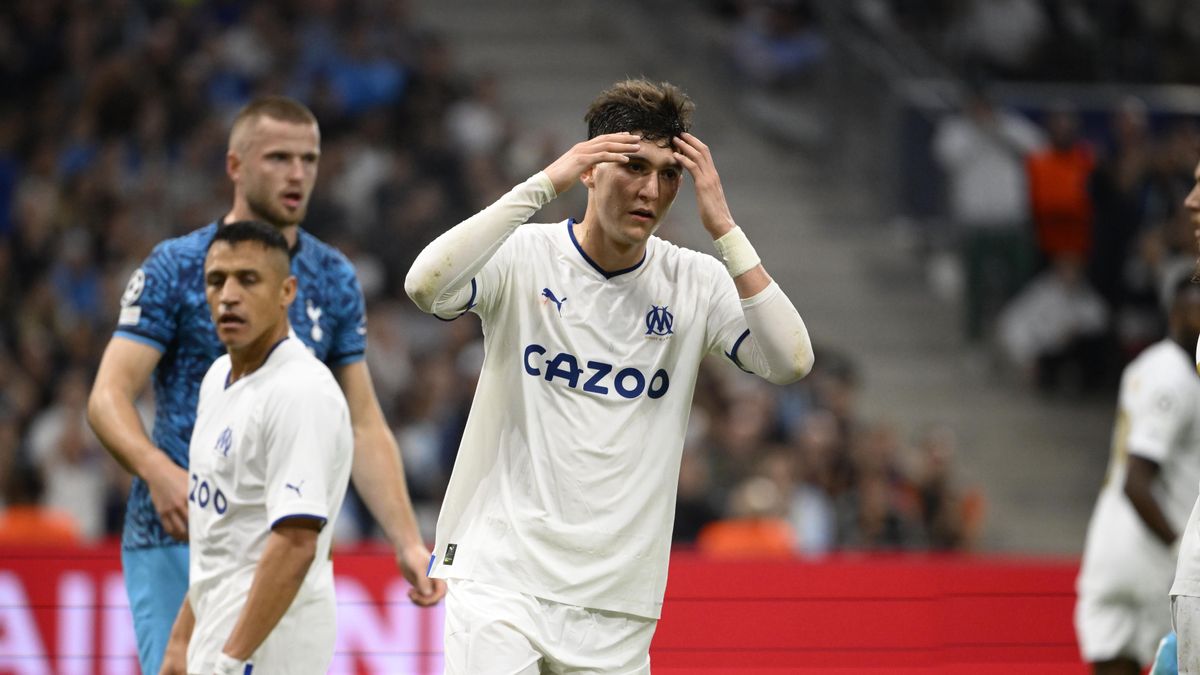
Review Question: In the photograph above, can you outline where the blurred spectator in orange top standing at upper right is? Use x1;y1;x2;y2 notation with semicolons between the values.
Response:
1028;102;1096;265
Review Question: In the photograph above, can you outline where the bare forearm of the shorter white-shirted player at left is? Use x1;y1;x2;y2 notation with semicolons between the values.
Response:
217;516;324;673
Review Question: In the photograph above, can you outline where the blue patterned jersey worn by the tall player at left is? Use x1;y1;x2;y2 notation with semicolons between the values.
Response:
115;222;367;549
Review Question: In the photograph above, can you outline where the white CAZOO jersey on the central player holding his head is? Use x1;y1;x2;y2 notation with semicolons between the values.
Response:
431;221;749;619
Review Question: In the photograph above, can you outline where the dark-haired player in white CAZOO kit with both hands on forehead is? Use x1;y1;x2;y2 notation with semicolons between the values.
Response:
406;79;812;674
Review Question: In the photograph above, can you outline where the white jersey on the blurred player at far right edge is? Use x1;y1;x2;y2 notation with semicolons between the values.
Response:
1078;340;1200;602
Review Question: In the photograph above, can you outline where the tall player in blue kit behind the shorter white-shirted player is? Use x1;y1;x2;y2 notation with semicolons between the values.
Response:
88;96;445;673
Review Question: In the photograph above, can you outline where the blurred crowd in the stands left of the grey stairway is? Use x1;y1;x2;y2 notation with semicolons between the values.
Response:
0;0;983;555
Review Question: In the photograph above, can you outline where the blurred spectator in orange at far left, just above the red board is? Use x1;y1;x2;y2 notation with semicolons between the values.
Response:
0;460;80;546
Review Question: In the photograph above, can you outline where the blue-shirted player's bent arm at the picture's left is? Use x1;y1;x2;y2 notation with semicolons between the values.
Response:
88;336;187;540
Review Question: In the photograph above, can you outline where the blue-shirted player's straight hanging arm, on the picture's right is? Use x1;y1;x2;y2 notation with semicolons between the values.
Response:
334;360;446;607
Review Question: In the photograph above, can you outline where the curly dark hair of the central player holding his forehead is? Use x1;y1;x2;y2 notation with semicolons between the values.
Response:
583;79;696;141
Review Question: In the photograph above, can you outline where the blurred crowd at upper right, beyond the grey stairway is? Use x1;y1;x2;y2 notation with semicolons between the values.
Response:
707;0;1200;396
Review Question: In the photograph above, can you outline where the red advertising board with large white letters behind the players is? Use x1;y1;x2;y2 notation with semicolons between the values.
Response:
0;545;1086;675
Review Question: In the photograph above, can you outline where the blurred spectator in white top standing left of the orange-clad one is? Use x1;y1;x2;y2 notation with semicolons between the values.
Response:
934;86;1043;342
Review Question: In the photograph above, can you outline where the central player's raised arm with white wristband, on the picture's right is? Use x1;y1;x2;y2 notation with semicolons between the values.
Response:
673;133;814;384
